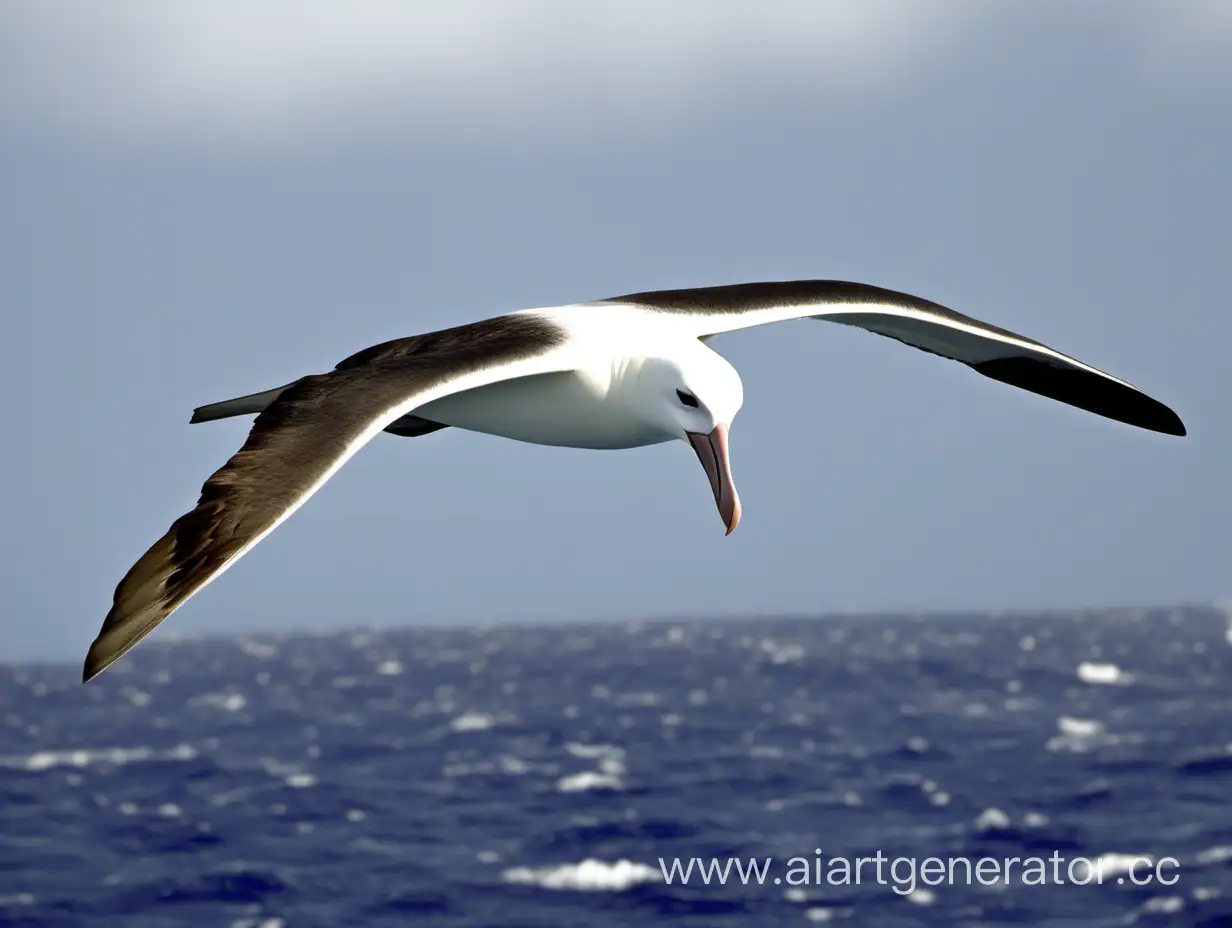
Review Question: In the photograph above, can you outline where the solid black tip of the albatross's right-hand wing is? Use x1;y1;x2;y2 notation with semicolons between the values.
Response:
971;357;1186;436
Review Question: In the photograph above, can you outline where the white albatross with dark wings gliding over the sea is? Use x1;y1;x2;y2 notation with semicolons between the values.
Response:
84;280;1185;680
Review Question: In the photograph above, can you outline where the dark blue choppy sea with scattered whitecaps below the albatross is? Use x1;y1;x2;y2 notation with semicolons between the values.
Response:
0;608;1232;928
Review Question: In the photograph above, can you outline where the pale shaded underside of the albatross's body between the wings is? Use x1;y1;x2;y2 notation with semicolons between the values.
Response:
413;372;673;449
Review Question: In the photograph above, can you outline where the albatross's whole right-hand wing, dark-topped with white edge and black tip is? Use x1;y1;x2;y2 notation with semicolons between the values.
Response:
602;280;1185;435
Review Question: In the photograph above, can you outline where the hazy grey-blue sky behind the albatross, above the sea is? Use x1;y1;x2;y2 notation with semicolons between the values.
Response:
0;0;1232;659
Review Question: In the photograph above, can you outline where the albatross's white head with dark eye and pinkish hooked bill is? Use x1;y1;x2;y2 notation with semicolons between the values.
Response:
636;340;744;535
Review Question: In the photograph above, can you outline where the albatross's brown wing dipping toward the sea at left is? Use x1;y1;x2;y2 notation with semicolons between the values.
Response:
83;313;575;680
